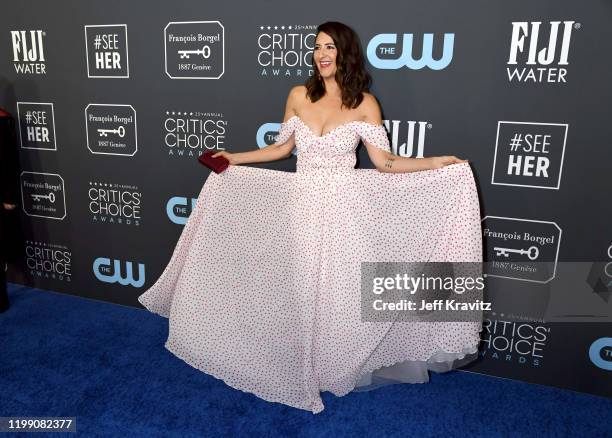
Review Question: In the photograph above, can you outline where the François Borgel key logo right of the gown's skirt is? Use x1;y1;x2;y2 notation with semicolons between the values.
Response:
482;216;561;283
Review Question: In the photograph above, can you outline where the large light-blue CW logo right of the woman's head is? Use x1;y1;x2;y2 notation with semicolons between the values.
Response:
366;33;455;70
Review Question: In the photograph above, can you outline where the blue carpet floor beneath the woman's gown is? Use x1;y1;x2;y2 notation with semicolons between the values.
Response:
0;285;612;438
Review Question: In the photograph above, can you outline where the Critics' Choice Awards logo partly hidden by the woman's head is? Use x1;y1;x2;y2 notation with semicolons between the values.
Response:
257;24;317;78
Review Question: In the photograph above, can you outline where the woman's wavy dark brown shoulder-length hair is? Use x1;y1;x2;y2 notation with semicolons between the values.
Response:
305;21;372;109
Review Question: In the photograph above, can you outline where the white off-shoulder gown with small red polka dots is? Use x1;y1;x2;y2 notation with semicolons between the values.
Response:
138;116;482;413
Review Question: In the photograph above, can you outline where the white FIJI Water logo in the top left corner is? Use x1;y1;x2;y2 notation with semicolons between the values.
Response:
11;30;47;75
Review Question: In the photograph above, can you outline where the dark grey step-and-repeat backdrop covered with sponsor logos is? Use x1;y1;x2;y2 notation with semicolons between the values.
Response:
0;0;612;396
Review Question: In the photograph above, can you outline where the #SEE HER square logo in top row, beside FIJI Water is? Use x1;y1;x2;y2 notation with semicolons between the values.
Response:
85;24;130;78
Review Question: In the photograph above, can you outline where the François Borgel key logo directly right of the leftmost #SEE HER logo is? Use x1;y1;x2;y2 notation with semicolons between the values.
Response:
85;103;138;156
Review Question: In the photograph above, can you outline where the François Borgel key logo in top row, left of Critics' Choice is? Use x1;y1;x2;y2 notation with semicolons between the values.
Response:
164;21;225;79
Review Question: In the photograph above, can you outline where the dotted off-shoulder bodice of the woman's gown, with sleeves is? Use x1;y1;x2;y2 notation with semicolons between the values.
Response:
276;115;391;172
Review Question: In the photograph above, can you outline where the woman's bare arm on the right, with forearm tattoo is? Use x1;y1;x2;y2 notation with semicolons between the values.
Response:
363;94;467;173
